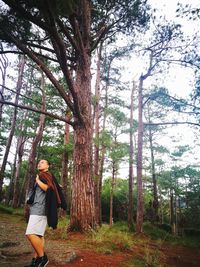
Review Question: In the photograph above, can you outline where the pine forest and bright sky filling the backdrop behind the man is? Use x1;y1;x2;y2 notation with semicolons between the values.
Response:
0;1;200;236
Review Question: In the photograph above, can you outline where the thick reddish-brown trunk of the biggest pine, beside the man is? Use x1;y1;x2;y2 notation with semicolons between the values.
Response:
68;0;96;231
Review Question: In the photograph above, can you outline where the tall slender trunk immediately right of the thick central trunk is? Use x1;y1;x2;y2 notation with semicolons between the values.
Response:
94;43;102;225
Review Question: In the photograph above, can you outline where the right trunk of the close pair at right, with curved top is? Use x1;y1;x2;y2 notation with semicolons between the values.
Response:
136;75;144;233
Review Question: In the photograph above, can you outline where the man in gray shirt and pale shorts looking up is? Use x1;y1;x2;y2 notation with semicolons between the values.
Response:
26;159;52;267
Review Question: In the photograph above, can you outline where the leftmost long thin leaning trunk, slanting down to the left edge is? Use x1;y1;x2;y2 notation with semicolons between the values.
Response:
0;56;25;200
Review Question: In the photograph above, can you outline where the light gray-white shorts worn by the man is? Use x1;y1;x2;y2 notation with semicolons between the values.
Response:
26;215;47;236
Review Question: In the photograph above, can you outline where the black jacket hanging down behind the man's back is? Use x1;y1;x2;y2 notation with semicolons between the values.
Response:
46;176;67;229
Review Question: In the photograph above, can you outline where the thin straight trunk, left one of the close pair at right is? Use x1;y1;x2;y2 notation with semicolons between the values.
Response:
128;82;135;231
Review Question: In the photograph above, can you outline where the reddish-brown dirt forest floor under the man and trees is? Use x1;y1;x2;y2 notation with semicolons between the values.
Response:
0;212;200;267
